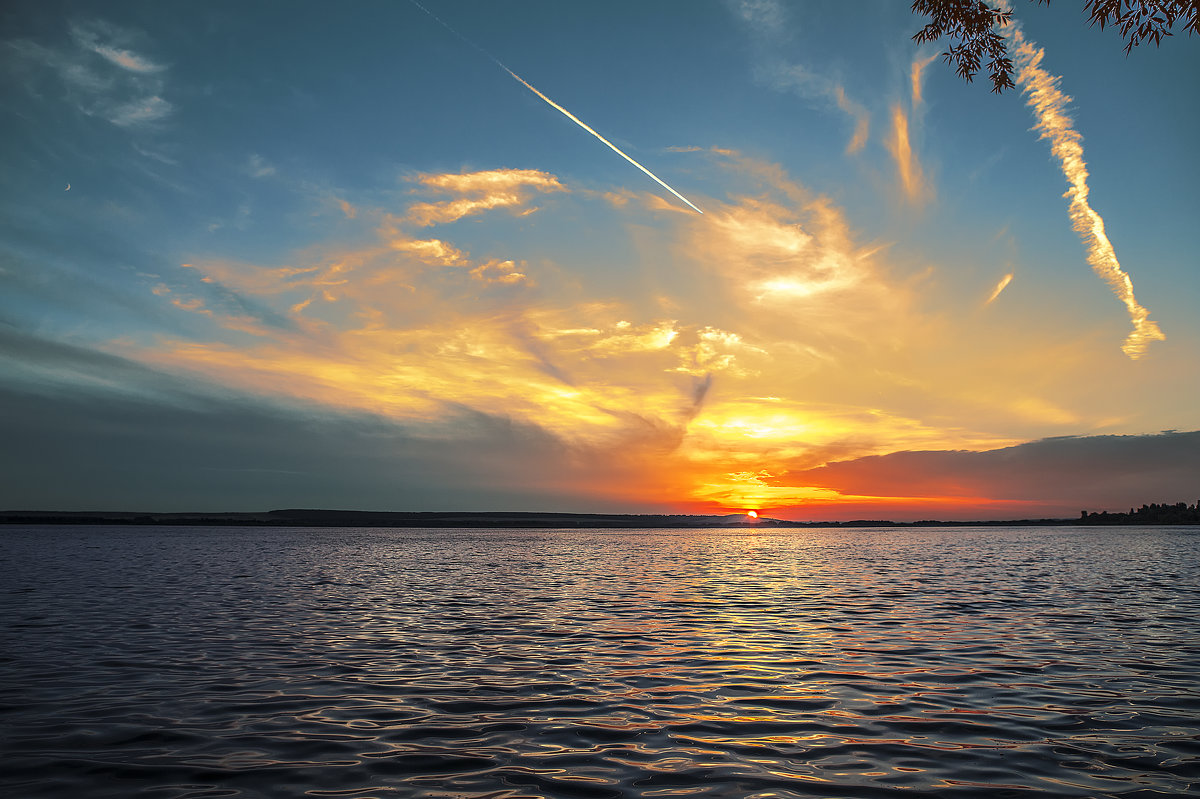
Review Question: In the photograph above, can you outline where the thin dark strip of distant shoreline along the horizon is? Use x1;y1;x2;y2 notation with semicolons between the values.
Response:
0;505;1200;529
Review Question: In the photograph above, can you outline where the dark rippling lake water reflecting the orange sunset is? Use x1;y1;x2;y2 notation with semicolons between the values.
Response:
0;527;1200;799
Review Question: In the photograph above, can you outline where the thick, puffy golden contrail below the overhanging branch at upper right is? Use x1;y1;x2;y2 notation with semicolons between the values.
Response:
1004;24;1166;360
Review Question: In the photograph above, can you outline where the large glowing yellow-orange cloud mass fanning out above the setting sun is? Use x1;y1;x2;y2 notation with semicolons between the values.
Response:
124;152;1142;509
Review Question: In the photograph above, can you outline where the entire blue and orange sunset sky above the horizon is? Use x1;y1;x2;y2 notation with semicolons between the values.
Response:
0;0;1200;519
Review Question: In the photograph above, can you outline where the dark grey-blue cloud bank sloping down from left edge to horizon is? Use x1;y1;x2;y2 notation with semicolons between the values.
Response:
0;325;656;511
